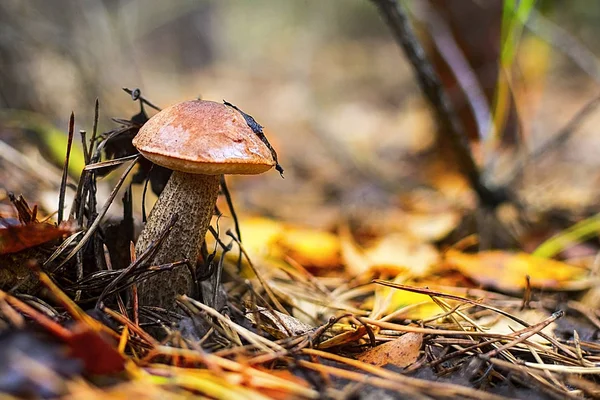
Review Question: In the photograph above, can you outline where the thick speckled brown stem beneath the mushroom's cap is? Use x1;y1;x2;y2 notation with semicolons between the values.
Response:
135;171;219;310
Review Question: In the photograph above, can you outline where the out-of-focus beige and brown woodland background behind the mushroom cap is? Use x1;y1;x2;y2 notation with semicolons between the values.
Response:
0;0;600;230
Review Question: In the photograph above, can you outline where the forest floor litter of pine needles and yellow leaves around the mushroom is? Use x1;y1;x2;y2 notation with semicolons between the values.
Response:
0;90;600;399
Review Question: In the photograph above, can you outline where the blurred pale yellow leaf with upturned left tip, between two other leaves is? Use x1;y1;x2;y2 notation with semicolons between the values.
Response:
340;230;440;277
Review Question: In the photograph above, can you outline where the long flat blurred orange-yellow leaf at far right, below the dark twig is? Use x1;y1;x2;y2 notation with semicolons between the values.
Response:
445;250;591;292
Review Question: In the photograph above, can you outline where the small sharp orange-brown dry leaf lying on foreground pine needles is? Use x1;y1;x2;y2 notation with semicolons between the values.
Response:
358;333;423;368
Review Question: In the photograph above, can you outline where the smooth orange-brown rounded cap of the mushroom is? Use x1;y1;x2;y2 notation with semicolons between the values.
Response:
133;100;275;175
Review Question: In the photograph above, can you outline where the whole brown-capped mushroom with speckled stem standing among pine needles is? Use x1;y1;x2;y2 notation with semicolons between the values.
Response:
133;100;276;309
